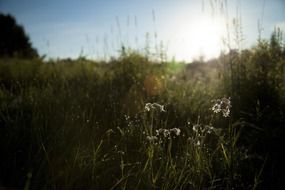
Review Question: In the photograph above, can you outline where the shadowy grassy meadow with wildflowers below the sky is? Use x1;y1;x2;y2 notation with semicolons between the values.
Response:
0;31;285;190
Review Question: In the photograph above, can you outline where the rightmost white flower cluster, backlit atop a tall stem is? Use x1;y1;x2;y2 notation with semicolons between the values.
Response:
211;98;231;117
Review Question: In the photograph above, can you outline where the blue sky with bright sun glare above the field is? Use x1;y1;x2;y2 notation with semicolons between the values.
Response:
0;0;285;62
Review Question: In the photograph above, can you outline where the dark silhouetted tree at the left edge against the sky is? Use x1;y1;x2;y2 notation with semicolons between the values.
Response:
0;13;38;58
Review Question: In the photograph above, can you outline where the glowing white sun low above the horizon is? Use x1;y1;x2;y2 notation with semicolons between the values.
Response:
169;17;226;61
